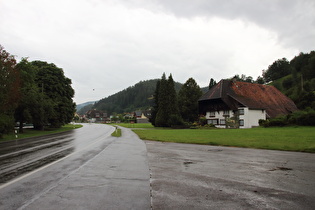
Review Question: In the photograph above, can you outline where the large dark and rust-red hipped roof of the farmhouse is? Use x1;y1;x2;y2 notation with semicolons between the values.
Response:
199;80;297;117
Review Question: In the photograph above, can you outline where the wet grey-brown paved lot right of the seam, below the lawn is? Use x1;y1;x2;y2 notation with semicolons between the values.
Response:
146;141;315;209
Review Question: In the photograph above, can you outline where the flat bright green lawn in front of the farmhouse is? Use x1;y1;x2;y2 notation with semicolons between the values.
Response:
133;127;315;153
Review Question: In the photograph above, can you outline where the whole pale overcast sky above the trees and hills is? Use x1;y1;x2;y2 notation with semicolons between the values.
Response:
0;0;315;104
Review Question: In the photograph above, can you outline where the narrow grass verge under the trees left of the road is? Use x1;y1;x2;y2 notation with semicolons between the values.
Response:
0;124;83;142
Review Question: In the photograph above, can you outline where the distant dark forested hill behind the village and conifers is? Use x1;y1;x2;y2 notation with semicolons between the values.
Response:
86;79;182;115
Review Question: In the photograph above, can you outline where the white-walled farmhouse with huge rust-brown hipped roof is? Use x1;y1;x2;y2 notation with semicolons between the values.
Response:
198;80;297;128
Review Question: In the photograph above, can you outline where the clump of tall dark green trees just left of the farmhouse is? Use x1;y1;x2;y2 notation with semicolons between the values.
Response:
151;73;202;127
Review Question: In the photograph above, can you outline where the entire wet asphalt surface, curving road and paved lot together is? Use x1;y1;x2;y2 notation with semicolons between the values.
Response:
0;124;315;210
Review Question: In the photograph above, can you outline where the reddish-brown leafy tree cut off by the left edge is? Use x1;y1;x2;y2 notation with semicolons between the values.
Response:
0;45;20;138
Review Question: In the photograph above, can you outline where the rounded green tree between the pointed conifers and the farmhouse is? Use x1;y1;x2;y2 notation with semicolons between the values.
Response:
178;78;202;122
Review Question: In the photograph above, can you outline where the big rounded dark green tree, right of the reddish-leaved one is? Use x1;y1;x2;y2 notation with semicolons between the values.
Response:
31;61;75;129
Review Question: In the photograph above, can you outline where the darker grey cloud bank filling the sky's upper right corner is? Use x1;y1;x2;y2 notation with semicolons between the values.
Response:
143;0;315;51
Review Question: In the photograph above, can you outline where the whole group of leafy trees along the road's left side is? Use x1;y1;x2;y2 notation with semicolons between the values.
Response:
0;45;75;137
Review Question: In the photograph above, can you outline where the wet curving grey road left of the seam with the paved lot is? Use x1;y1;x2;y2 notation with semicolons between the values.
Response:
0;124;150;210
